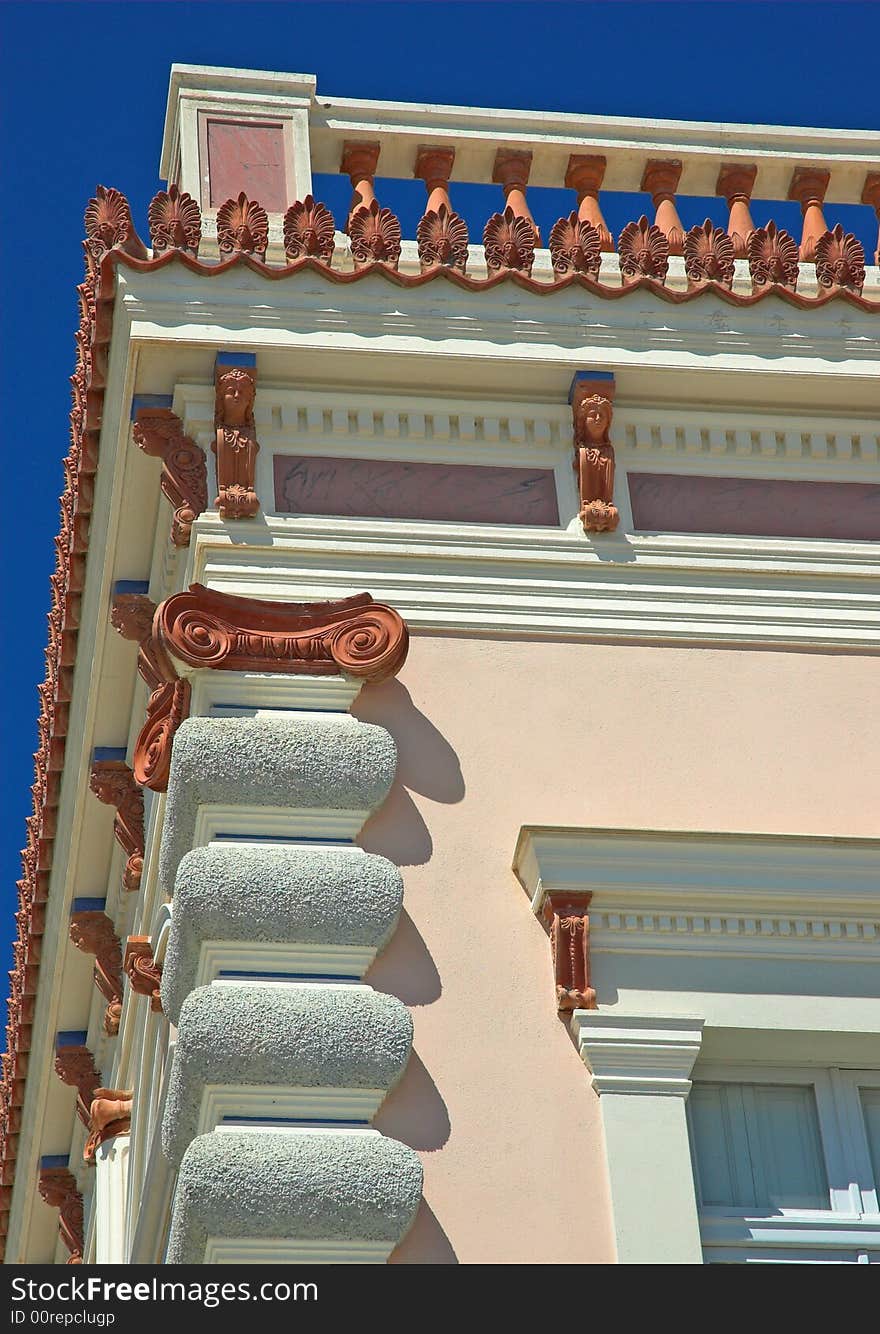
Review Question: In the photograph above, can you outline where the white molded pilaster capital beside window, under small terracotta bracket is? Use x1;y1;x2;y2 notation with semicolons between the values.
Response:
571;1010;703;1098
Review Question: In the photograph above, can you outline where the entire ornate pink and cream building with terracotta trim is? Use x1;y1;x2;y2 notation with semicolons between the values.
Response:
1;65;880;1263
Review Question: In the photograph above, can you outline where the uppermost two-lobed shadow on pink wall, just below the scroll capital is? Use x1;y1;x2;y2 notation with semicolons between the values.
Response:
352;680;464;866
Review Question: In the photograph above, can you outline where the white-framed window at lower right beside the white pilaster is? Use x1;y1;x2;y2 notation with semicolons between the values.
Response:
688;1066;880;1265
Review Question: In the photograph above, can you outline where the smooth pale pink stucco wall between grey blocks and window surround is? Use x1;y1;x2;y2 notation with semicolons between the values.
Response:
353;636;880;1263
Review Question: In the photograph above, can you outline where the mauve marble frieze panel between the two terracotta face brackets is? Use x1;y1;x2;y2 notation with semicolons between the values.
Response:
275;454;559;527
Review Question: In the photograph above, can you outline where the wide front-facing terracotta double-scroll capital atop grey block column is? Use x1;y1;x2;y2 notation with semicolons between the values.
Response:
155;584;409;682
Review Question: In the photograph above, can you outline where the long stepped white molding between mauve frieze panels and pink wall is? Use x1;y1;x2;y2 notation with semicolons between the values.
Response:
189;514;880;652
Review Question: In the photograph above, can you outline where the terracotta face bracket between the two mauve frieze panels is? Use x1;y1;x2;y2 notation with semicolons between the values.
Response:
568;372;620;532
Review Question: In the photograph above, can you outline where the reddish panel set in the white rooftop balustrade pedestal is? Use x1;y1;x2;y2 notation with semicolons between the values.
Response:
208;120;286;213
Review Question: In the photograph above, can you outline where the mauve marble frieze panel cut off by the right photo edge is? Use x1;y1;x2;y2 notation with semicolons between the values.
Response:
628;472;880;542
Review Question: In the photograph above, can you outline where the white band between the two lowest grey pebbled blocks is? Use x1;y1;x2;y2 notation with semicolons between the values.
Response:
196;1083;387;1135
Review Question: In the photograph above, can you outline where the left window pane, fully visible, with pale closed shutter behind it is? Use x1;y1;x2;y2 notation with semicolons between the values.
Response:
688;1083;829;1209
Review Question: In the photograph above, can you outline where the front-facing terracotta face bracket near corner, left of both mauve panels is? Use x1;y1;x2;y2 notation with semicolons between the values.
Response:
213;366;260;519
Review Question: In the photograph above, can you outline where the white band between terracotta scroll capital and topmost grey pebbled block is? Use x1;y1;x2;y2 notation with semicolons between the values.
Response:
189;670;364;718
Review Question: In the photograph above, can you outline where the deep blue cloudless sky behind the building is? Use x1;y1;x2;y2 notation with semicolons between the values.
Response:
0;0;880;967
